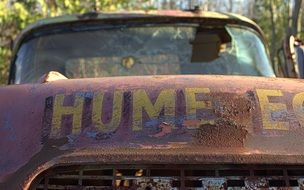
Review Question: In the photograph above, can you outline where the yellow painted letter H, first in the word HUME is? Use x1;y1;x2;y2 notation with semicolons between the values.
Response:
51;94;84;136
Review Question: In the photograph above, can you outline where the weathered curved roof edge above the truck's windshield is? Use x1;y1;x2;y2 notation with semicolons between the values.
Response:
14;10;264;50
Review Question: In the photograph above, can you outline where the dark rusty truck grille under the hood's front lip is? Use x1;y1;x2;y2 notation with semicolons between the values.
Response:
30;165;304;190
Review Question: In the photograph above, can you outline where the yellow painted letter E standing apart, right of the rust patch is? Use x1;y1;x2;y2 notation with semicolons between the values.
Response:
256;89;289;130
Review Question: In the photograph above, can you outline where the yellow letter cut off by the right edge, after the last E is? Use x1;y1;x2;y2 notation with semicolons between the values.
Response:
292;92;304;127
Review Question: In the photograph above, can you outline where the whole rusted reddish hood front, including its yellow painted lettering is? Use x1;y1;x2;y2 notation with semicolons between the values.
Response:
0;75;304;189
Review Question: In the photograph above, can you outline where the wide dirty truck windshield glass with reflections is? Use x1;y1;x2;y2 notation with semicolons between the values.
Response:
15;25;274;84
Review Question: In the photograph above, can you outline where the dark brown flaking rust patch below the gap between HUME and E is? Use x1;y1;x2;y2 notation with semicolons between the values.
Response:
195;118;248;147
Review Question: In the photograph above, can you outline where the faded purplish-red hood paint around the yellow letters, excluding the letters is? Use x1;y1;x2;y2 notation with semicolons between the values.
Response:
0;76;304;189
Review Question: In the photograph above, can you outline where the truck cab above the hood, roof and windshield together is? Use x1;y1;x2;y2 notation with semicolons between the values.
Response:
10;12;275;84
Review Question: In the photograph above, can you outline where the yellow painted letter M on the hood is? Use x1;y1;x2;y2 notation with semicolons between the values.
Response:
133;89;175;131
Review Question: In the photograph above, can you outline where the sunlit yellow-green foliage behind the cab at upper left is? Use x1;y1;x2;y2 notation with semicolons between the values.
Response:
0;0;151;85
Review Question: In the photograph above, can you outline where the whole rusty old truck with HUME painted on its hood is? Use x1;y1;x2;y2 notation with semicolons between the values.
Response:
0;10;304;190
